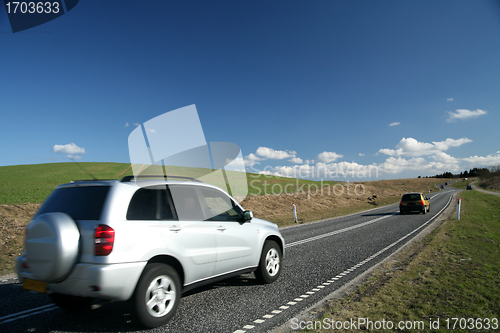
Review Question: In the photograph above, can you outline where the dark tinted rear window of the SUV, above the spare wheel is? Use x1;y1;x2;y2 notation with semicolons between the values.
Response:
36;186;109;220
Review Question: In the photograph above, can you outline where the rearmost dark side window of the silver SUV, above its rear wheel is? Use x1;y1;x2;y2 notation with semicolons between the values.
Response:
127;186;175;220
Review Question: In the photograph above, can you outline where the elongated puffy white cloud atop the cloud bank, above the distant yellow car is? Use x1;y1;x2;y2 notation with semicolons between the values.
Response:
379;137;472;157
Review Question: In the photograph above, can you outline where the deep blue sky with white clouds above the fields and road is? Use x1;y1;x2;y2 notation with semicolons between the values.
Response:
0;0;500;180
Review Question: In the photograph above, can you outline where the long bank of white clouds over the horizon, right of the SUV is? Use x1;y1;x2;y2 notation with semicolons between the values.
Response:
245;137;500;180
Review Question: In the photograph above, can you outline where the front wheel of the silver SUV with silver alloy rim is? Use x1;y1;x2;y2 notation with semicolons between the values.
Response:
255;241;283;283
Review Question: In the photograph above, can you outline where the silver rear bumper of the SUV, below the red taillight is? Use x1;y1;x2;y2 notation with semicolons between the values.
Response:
16;256;147;301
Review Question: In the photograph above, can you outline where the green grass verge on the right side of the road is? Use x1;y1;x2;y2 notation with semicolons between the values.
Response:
307;191;500;332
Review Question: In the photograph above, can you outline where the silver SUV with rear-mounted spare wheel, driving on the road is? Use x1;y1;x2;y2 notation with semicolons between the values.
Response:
16;177;285;328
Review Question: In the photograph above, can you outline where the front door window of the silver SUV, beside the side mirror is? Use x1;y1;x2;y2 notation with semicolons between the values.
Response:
200;188;243;221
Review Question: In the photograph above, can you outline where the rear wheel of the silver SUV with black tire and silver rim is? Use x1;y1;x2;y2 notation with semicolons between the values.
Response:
132;263;182;328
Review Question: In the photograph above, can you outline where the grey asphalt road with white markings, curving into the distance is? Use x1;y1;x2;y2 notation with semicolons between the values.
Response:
0;188;455;333
